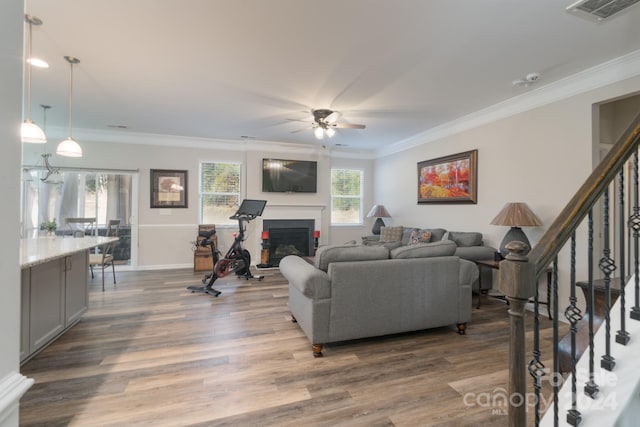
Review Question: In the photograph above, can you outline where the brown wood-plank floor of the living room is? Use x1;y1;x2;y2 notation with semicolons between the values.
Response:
20;270;551;426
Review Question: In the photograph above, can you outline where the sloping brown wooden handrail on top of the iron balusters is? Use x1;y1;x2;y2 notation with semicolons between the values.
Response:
528;114;640;277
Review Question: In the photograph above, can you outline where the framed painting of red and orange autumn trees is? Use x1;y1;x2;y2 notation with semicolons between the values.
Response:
418;150;478;204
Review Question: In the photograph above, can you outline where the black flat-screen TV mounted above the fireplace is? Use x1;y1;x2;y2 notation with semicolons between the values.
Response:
262;159;318;193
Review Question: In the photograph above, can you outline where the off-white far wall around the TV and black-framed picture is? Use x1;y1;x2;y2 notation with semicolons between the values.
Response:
24;137;373;269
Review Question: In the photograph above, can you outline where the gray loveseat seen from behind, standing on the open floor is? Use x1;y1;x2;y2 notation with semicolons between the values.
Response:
280;240;478;356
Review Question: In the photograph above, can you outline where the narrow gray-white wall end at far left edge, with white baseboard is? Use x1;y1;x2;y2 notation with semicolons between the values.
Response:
0;0;33;427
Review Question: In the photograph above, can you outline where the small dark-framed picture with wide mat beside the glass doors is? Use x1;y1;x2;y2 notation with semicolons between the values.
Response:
150;169;188;208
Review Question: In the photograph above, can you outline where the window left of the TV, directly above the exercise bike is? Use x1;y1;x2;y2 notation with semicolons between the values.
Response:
200;162;240;225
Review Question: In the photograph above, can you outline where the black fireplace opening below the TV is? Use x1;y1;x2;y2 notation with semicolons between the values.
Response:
262;219;315;267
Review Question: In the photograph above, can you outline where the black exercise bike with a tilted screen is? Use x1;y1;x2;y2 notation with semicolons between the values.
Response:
187;199;267;297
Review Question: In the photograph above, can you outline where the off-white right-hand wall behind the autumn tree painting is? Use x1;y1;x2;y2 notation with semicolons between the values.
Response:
374;77;640;310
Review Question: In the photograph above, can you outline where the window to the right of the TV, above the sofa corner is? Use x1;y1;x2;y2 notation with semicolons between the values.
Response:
331;169;362;224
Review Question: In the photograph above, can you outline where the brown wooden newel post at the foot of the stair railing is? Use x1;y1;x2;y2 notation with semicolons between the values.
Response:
498;241;536;427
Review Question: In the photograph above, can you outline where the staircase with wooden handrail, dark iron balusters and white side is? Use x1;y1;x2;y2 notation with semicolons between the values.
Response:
499;115;640;427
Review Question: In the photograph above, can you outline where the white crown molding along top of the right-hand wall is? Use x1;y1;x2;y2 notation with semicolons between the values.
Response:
375;50;640;158
